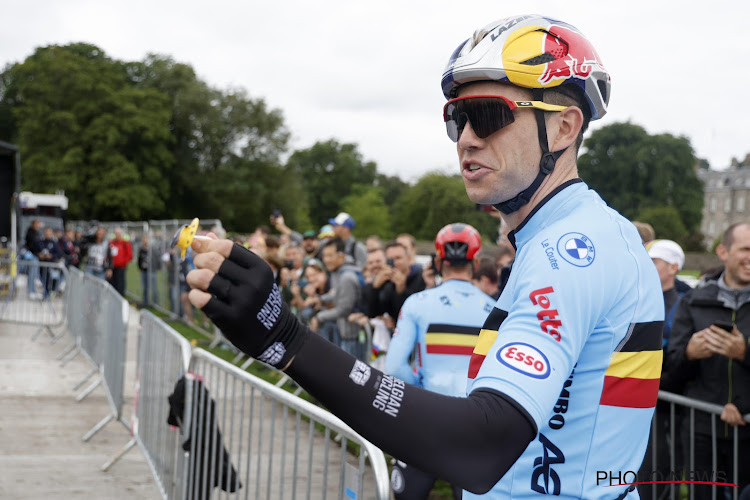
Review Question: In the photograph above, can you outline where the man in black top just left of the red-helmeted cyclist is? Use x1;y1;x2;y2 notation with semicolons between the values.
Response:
367;242;425;318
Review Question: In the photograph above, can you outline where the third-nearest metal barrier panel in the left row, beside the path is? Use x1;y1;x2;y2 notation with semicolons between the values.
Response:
58;268;130;441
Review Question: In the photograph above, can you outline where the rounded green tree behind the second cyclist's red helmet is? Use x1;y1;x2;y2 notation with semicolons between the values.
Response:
393;173;498;241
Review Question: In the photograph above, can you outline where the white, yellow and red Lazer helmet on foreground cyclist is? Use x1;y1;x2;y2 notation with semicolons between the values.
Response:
442;15;610;120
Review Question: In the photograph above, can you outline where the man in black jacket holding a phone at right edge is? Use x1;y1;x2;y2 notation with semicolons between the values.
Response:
665;223;750;499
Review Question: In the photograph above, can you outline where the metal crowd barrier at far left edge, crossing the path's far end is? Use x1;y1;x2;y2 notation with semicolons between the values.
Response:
0;256;68;340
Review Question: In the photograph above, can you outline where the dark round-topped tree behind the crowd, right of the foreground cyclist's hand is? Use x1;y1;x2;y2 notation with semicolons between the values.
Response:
286;139;377;225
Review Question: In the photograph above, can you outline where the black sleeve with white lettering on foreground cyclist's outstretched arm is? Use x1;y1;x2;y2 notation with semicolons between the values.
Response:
288;325;537;493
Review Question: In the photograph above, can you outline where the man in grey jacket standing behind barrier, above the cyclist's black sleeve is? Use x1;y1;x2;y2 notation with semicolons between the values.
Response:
310;237;365;361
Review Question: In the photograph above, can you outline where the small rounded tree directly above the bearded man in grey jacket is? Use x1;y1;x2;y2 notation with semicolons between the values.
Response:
341;184;391;240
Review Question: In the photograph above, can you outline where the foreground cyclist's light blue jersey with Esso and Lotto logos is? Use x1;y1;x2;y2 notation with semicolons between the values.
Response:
464;179;664;500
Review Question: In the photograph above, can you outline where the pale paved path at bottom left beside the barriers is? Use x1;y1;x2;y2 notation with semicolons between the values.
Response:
0;302;160;500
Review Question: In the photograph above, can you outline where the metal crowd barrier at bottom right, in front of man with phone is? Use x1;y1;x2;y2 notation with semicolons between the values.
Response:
638;391;750;500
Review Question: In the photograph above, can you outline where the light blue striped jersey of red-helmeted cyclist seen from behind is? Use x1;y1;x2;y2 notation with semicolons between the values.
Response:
385;279;495;397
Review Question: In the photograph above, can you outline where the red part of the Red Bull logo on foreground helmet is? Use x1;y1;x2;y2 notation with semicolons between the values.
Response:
539;25;602;87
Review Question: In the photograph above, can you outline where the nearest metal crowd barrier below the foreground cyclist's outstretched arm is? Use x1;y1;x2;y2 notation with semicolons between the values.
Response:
183;349;390;500
